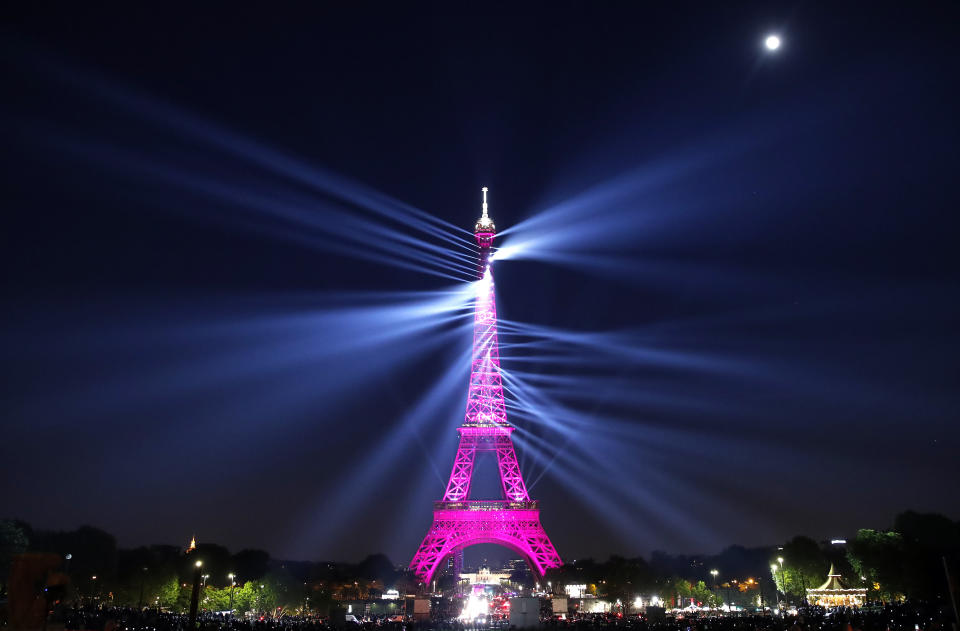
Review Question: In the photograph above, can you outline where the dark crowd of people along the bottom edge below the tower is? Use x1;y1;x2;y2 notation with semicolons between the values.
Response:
56;603;953;631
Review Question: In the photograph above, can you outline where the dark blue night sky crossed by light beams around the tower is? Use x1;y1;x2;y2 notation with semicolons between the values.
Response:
0;2;960;563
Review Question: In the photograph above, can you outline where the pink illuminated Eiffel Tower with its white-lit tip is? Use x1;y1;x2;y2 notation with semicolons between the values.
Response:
410;187;563;583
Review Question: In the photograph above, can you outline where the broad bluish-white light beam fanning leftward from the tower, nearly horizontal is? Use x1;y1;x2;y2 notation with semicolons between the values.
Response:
9;285;472;432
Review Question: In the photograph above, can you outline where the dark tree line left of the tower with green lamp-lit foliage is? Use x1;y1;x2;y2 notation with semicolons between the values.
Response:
0;519;416;611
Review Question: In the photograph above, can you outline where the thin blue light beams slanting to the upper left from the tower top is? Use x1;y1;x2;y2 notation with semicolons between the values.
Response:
9;50;475;286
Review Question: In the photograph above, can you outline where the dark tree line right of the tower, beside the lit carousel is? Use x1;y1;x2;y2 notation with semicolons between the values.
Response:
547;511;960;602
